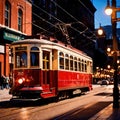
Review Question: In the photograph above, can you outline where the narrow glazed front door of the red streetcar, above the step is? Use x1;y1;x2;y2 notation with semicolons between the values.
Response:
42;51;50;91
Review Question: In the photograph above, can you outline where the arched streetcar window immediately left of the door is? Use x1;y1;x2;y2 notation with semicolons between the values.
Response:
30;47;39;66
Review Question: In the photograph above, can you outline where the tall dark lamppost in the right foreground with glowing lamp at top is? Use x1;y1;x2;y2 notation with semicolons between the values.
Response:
105;0;120;108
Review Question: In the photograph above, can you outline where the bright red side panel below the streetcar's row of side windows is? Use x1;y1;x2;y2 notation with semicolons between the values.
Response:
58;71;92;90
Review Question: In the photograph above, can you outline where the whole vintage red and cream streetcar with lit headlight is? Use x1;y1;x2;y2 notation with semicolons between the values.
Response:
10;38;93;99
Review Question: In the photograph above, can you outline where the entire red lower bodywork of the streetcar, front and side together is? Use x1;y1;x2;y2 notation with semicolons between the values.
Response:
14;69;92;98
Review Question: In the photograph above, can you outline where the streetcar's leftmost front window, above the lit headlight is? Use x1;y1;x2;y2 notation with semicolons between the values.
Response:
15;51;27;67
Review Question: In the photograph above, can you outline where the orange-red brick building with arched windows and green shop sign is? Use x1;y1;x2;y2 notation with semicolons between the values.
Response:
0;0;32;76
